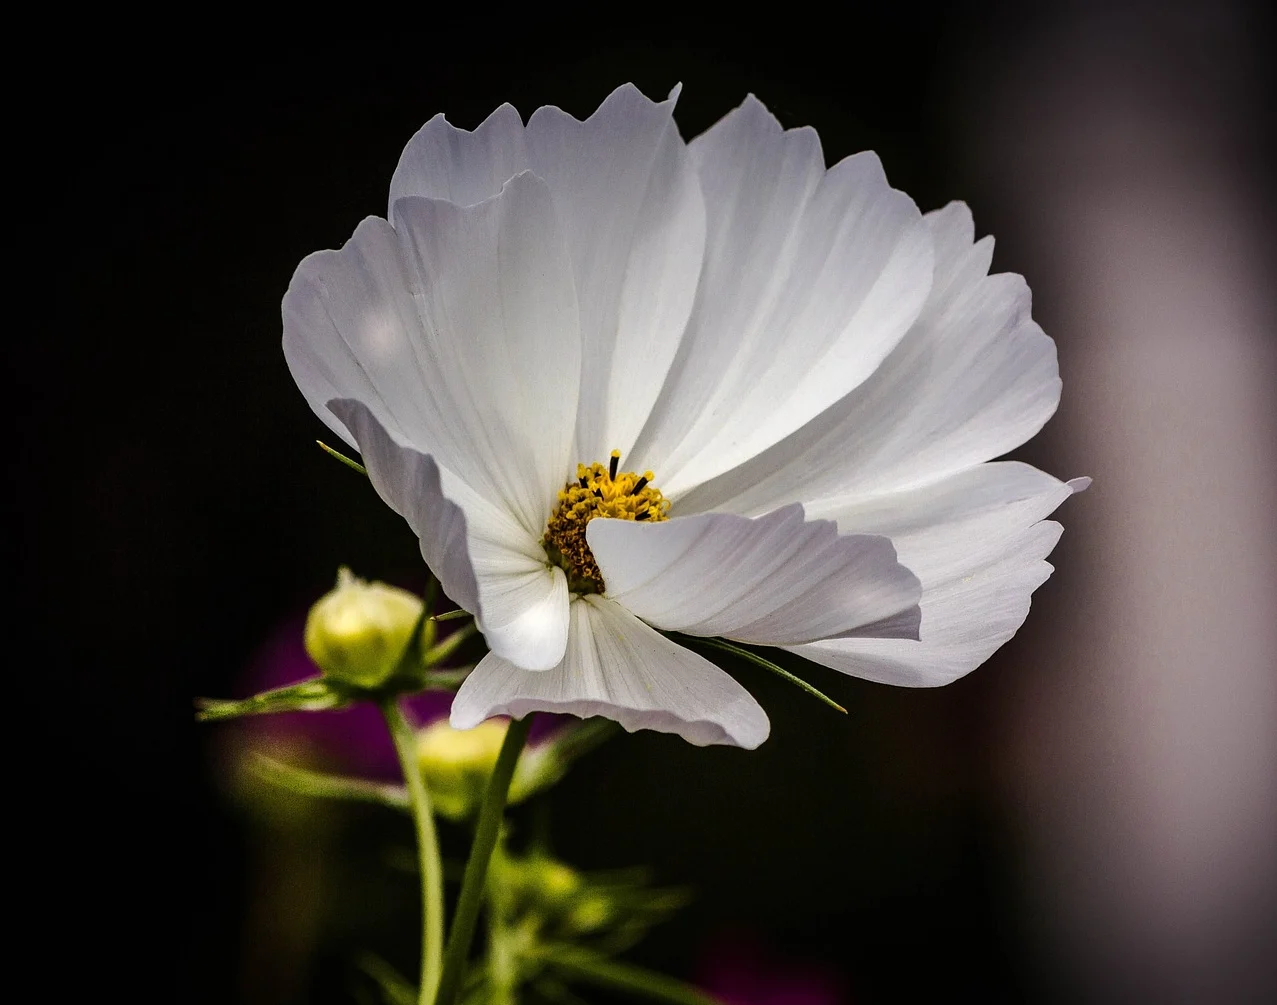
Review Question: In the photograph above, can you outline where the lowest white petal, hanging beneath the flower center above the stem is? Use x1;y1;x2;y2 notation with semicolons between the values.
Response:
452;595;770;750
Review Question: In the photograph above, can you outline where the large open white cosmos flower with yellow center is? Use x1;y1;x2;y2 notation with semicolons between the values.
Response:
283;86;1074;747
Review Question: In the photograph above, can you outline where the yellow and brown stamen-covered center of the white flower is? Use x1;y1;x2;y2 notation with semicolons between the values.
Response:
541;451;669;594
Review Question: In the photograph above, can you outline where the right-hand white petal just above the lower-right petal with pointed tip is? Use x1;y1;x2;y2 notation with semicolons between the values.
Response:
684;203;1060;513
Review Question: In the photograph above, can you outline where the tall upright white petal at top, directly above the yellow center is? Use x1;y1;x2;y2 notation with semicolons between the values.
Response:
526;84;705;461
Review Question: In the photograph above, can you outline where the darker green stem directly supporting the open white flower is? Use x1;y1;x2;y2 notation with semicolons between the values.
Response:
435;714;533;1005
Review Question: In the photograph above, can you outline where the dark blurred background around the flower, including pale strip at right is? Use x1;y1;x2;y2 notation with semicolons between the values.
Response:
24;0;1277;1005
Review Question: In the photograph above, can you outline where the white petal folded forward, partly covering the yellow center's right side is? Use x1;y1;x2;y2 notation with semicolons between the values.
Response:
586;504;921;645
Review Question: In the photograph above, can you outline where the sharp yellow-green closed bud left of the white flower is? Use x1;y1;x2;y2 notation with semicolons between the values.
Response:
305;567;421;687
